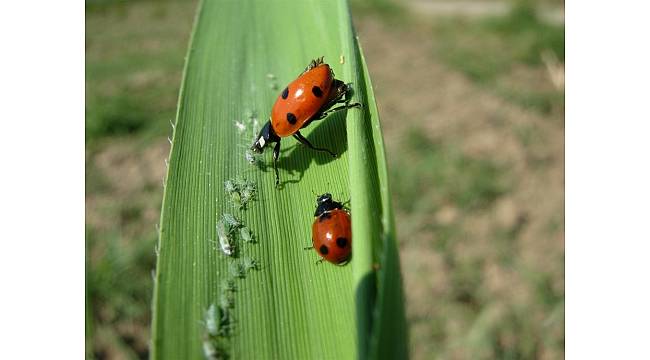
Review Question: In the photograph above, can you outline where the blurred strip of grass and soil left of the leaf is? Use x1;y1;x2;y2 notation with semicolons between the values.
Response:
85;1;195;358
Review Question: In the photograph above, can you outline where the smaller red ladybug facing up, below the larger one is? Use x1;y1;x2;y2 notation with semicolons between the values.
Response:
311;194;352;265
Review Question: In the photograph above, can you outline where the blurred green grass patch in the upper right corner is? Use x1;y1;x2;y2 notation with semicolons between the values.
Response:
434;1;564;114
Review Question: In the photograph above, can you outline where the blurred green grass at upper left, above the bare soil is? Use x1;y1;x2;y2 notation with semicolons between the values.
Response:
86;1;192;147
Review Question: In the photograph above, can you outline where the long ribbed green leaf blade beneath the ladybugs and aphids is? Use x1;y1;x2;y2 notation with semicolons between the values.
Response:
151;0;408;359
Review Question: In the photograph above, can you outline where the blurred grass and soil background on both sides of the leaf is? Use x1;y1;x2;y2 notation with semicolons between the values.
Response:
86;0;564;359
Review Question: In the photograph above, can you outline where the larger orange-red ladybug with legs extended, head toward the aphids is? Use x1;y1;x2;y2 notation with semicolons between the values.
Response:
251;57;361;186
